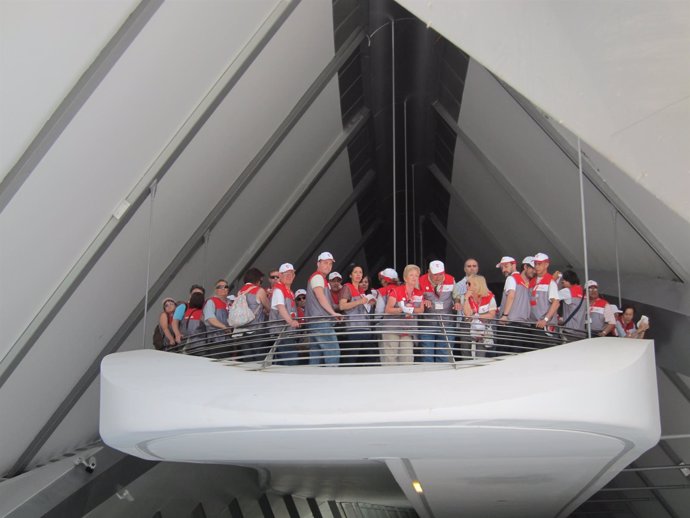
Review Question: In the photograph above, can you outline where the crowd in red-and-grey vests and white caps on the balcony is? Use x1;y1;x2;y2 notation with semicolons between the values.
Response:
154;252;649;365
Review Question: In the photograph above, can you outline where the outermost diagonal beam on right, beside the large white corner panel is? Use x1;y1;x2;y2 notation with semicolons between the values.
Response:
496;78;690;282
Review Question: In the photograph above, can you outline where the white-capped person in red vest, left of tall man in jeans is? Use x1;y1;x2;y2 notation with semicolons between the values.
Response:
269;263;299;365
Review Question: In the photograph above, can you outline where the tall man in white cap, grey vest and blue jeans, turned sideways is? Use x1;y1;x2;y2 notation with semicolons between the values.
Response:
305;252;341;365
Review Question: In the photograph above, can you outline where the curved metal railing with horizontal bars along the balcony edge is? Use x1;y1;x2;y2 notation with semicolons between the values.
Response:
167;314;587;369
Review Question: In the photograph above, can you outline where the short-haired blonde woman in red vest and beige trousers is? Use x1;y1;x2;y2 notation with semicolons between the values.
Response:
381;264;424;364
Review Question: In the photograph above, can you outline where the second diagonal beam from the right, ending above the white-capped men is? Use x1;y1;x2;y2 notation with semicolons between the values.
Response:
433;101;582;265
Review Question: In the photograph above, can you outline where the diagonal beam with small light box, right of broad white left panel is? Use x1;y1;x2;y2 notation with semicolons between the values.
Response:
0;1;298;387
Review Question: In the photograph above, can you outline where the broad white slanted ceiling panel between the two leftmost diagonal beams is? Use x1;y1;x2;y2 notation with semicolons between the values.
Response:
0;2;280;354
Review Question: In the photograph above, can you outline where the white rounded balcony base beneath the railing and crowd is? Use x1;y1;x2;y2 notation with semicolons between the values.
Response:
100;339;660;518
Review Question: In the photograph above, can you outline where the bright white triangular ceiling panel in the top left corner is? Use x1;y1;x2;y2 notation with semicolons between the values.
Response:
0;0;138;176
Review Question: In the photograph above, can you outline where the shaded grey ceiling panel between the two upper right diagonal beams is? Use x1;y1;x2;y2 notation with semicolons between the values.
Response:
456;61;673;284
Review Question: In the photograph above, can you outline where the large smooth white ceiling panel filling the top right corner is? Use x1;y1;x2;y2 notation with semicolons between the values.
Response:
397;0;690;226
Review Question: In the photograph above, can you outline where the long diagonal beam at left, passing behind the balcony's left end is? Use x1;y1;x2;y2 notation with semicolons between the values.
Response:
2;23;364;476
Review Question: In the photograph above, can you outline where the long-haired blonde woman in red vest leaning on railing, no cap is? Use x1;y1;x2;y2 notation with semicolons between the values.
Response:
463;274;497;358
